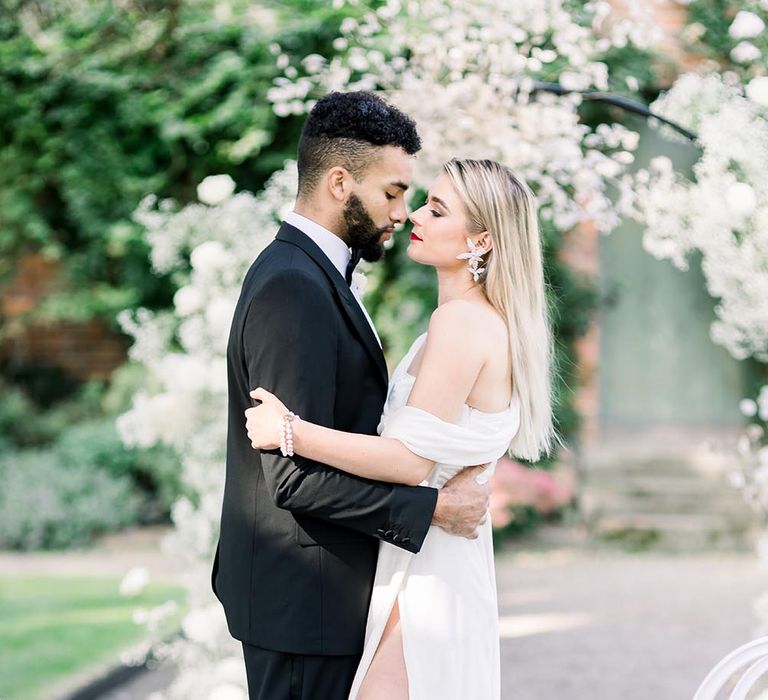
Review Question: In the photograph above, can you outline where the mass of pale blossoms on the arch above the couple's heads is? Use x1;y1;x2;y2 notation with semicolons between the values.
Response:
268;0;655;232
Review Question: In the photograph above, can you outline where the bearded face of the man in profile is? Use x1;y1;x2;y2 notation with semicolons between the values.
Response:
342;146;414;262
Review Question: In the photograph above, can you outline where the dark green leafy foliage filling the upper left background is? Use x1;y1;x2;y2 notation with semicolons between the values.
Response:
0;0;354;321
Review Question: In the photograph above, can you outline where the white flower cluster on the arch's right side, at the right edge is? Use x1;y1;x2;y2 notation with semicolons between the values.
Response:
636;74;768;361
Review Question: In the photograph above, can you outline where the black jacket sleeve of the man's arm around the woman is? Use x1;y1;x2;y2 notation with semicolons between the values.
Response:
243;270;437;552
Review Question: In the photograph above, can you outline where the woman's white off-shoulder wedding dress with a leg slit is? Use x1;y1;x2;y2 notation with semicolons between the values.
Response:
349;333;520;700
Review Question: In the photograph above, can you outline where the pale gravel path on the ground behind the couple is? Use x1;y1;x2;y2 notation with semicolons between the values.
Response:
6;528;768;700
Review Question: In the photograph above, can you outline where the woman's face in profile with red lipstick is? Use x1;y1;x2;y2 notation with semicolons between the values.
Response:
408;173;487;269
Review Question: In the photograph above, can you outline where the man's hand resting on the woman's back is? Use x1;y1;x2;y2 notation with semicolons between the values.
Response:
432;464;491;540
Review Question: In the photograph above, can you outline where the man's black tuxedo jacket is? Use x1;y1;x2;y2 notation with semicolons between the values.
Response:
212;224;437;655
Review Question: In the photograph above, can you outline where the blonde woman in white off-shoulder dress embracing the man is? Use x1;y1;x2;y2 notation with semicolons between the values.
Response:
245;160;556;700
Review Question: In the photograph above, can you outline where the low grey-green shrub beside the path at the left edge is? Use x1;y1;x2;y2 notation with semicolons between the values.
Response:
0;450;139;549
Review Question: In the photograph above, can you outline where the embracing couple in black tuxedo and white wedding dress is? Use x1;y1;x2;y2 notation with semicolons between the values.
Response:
213;92;555;700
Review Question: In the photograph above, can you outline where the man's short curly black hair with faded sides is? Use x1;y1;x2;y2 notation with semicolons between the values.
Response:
298;91;421;195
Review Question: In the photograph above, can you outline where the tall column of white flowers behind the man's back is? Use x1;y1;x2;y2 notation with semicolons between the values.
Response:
118;162;296;700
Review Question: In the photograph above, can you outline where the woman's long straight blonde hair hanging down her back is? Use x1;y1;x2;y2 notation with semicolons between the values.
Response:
443;159;560;461
